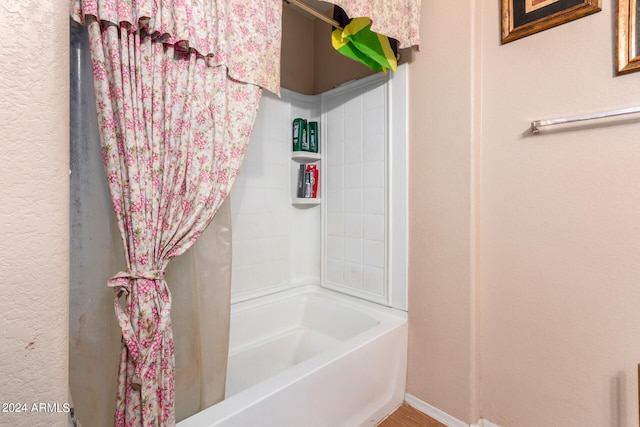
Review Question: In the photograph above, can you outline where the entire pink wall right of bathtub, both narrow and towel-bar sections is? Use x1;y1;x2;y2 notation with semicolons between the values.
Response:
408;0;640;427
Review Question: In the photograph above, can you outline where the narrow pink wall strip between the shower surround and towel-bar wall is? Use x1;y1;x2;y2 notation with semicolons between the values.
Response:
407;0;478;427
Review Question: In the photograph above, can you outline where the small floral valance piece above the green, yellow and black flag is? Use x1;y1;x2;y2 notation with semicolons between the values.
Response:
331;0;422;48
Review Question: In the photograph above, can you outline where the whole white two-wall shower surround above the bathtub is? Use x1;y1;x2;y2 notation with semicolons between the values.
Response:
231;65;407;309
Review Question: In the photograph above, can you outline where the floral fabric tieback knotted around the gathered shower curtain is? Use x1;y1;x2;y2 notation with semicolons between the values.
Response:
107;270;171;390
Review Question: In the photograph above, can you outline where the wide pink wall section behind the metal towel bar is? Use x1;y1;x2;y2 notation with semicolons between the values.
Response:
478;0;640;427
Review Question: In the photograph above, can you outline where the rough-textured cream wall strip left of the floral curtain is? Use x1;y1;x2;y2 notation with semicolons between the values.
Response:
0;0;69;427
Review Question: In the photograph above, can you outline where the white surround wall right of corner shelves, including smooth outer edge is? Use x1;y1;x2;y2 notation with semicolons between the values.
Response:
321;66;407;310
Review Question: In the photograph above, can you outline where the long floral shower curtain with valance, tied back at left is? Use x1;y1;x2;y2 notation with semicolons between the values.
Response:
71;0;282;427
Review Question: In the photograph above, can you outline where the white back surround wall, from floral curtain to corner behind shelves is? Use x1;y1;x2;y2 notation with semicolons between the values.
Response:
231;89;320;303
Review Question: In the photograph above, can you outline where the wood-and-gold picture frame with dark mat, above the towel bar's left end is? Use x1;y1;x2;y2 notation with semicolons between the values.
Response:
501;0;604;44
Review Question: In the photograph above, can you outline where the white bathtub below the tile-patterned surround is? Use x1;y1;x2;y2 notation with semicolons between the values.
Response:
178;286;407;427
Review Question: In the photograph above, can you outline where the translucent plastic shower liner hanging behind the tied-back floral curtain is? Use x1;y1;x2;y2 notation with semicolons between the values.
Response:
69;20;231;427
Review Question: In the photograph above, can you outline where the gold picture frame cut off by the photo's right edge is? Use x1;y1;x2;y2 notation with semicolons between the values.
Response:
616;0;640;74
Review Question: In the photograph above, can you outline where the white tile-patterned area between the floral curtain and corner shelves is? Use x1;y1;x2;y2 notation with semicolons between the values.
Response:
231;92;291;296
